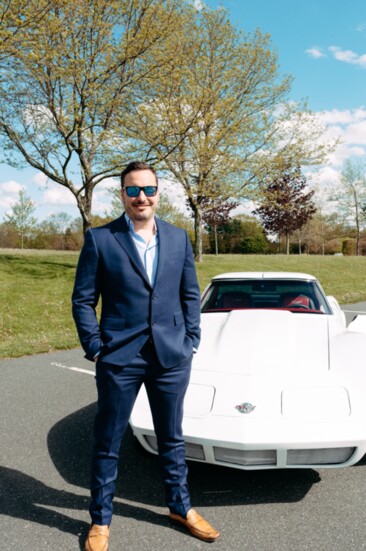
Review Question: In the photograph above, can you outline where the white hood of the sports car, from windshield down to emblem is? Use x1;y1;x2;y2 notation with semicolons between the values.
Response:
185;309;351;422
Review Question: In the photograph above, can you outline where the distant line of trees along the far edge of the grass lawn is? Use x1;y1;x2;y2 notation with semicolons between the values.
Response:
0;181;366;255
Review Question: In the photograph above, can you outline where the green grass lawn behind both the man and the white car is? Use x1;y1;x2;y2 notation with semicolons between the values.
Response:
0;249;366;358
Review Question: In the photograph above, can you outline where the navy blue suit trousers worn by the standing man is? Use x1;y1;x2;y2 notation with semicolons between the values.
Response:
89;339;192;525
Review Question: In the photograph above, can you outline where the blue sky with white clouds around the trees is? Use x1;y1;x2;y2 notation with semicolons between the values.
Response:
0;0;366;221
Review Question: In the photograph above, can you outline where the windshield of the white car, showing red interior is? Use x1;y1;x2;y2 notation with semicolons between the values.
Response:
201;279;332;314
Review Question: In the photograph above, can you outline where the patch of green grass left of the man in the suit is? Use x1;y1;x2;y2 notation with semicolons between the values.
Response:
0;251;78;358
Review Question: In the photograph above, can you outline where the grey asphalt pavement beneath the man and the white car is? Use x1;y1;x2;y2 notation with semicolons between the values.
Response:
0;303;366;551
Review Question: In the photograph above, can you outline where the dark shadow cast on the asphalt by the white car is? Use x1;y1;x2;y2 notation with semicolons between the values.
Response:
48;404;320;512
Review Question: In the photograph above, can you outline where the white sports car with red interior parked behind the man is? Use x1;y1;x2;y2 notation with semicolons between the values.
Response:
130;272;366;469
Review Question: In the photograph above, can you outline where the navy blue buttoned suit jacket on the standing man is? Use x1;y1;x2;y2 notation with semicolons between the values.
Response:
72;215;200;368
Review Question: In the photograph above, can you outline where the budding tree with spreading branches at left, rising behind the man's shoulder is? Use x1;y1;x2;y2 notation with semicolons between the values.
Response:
0;0;182;231
